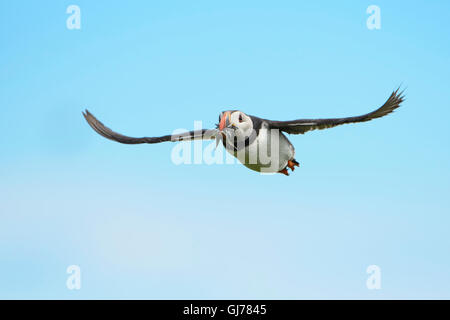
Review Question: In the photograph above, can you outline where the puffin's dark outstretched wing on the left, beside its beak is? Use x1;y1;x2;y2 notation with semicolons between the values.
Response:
83;110;217;144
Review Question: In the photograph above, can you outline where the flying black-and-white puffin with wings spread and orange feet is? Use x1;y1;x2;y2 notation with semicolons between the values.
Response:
83;88;404;176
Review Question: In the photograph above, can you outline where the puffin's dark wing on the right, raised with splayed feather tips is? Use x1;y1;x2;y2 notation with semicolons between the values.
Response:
267;89;404;134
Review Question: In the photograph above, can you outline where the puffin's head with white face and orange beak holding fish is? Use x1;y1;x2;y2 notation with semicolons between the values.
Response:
217;110;253;138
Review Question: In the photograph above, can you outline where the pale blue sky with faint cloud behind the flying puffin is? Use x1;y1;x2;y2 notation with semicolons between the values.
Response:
0;1;450;299
